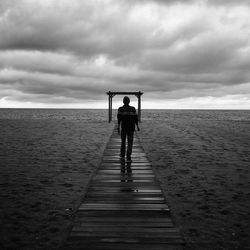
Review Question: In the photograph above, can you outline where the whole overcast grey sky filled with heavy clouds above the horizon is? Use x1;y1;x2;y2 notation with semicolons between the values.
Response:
0;0;250;109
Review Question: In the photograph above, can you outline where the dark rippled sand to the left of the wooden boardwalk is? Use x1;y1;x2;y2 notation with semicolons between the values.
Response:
0;119;113;249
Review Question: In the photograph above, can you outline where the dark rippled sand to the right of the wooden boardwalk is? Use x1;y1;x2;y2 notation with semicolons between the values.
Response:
138;118;250;249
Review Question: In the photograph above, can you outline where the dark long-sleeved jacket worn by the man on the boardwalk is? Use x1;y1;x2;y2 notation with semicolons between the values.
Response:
117;105;138;132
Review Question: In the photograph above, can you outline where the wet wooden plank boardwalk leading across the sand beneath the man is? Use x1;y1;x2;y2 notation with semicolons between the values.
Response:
63;131;183;250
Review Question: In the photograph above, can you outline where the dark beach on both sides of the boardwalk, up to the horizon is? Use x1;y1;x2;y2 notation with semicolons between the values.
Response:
0;110;250;249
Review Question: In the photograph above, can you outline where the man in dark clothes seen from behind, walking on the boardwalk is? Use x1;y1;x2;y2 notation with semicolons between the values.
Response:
117;96;140;162
